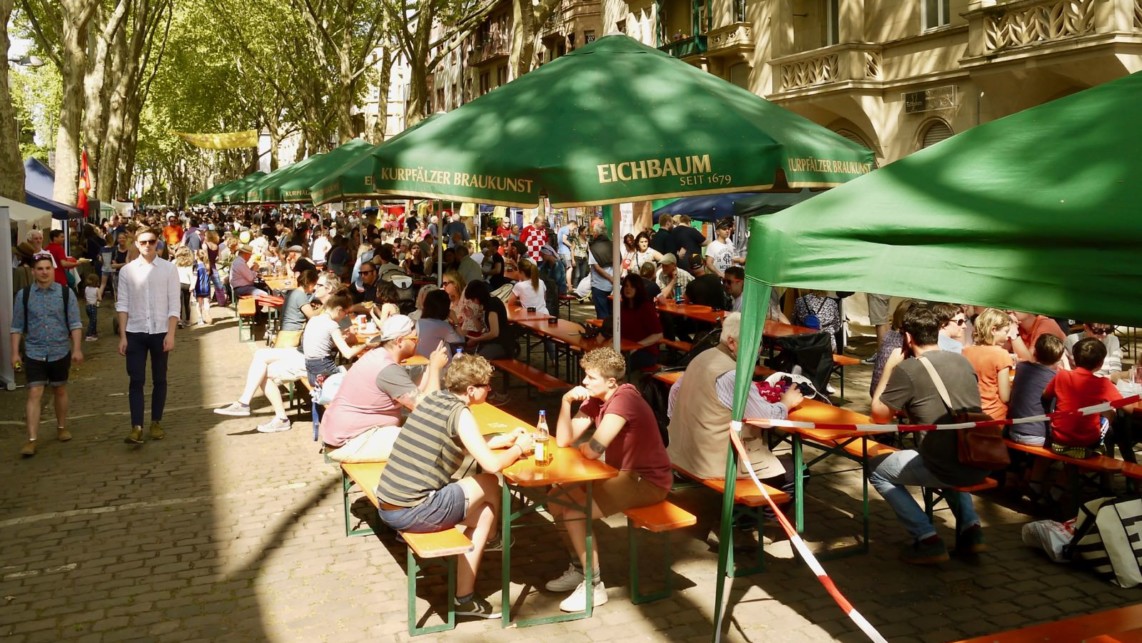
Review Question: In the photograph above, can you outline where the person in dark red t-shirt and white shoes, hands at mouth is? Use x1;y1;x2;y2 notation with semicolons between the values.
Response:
546;348;673;612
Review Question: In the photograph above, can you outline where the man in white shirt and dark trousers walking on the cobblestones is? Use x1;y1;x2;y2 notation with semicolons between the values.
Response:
115;228;179;444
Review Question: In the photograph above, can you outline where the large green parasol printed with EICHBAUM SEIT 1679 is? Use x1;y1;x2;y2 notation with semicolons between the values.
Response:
373;35;872;208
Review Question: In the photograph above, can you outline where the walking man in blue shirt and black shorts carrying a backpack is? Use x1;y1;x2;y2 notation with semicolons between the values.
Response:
11;251;83;458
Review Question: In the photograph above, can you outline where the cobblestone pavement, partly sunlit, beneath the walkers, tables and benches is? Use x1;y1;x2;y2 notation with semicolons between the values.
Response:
0;307;1137;643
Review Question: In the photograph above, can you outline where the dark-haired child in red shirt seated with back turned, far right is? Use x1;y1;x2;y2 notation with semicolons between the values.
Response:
1043;337;1123;458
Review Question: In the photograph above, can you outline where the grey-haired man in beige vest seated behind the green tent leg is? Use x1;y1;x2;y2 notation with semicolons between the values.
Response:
667;313;803;488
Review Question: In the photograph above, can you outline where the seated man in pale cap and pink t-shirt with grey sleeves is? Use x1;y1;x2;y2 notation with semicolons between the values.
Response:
321;315;448;463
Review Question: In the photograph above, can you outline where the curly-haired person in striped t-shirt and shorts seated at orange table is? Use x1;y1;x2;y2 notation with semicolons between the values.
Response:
377;354;532;619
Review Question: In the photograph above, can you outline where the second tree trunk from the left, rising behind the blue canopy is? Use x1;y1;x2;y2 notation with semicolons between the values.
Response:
51;0;97;206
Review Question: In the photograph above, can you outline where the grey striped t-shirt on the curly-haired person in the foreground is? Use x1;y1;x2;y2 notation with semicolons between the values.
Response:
377;391;465;507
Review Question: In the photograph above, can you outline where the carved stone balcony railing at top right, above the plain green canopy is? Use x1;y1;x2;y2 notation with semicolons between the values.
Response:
982;0;1100;54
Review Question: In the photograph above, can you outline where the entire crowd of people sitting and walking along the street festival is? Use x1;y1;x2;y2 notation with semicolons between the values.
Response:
11;203;1134;618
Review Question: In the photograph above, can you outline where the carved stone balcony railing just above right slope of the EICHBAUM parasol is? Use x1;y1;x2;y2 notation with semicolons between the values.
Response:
770;45;882;91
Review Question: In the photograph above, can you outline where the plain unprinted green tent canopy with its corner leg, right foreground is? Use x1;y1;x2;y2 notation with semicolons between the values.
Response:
734;73;1142;418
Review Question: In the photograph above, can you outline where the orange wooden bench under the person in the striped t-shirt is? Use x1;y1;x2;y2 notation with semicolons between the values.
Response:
341;463;472;636
